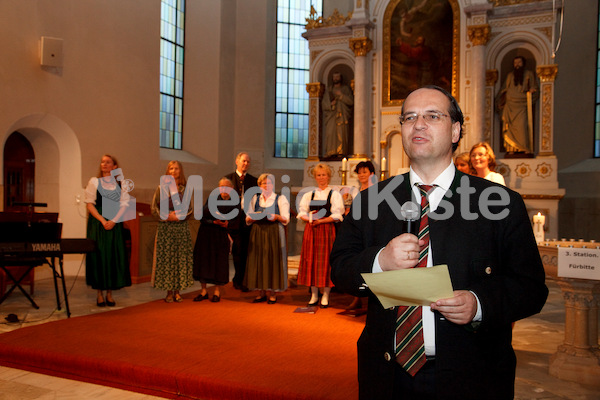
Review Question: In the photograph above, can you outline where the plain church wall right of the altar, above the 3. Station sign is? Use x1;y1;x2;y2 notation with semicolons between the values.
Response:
554;0;600;241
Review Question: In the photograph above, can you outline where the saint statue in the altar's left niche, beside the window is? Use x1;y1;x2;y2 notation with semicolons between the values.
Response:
321;72;354;157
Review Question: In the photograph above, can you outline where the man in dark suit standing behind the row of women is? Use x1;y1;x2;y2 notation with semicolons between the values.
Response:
225;152;258;292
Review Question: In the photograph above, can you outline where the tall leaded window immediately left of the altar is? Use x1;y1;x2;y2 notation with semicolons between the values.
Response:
275;0;323;158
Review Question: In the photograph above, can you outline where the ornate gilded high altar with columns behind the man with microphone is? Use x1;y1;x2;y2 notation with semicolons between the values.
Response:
302;0;565;238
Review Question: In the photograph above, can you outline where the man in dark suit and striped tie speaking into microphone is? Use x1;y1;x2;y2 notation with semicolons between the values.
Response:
331;86;548;400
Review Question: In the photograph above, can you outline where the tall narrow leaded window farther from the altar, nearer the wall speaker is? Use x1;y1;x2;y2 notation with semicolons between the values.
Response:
160;0;185;150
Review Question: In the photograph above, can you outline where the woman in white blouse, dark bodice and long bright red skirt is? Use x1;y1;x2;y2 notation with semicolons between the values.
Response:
298;164;345;308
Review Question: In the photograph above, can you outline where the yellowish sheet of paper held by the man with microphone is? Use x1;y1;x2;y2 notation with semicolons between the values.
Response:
361;264;454;308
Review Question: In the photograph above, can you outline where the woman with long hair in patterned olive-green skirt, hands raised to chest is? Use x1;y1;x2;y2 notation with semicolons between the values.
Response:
151;161;194;303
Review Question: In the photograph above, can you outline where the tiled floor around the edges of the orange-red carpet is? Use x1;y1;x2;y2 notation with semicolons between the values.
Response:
0;268;600;400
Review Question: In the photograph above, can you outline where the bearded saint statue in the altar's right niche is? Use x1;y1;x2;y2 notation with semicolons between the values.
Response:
496;56;538;156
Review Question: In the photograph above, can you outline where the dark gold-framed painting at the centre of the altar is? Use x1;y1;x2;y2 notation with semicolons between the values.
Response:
383;0;459;106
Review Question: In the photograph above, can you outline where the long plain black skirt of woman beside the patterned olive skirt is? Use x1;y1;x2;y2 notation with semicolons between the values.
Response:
194;222;230;285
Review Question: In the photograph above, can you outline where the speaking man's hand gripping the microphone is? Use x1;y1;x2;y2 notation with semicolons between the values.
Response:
379;233;425;271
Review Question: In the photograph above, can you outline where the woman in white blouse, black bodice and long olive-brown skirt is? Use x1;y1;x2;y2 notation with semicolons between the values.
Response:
244;174;290;304
